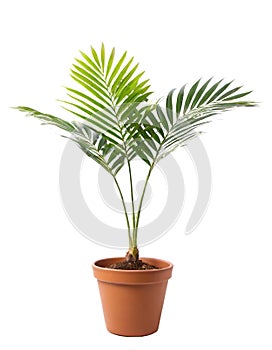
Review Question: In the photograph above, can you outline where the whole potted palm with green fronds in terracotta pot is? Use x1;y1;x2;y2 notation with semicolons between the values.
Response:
16;44;256;336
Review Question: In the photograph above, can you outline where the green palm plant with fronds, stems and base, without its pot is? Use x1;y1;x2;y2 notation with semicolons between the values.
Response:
16;44;256;261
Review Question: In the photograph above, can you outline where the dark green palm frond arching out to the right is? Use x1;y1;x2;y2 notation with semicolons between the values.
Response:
130;79;256;165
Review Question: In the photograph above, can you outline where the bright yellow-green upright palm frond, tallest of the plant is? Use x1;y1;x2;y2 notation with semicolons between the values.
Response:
62;44;151;144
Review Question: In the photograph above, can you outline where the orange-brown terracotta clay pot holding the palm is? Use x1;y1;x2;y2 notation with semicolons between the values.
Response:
93;258;173;337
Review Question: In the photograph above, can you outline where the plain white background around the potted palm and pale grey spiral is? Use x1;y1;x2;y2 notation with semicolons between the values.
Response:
0;0;272;350
